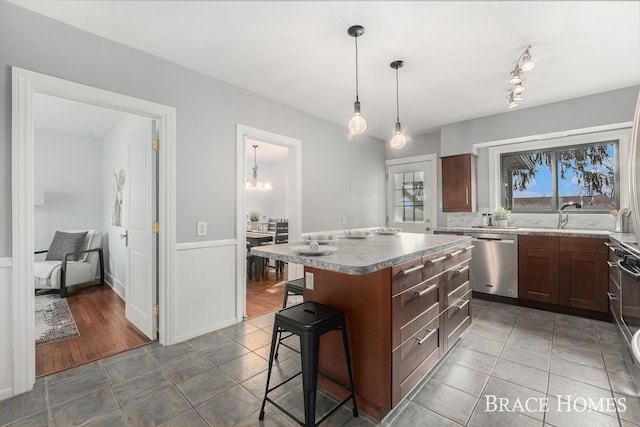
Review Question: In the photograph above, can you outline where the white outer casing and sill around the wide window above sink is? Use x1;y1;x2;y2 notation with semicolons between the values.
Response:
490;127;631;215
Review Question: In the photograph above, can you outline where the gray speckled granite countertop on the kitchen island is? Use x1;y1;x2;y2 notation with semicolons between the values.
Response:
251;233;471;274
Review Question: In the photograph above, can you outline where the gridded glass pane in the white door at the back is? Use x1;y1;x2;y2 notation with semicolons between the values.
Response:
393;172;424;222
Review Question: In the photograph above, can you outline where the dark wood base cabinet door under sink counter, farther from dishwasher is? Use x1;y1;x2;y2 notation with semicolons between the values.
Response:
560;238;609;313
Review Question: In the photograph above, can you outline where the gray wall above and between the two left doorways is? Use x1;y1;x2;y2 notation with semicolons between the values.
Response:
0;0;385;257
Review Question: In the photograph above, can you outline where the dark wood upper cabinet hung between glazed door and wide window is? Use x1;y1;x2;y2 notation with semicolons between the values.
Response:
441;154;476;212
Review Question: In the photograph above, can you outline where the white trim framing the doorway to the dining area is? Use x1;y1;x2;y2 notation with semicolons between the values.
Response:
236;123;302;321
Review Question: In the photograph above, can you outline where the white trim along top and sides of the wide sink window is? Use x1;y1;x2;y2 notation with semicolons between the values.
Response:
490;128;631;213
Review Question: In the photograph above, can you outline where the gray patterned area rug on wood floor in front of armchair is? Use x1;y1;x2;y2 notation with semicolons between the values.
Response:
36;294;80;345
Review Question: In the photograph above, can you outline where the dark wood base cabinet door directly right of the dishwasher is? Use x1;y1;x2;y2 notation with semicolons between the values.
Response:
518;236;559;304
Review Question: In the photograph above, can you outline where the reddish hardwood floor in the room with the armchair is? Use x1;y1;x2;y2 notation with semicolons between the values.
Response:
36;285;151;377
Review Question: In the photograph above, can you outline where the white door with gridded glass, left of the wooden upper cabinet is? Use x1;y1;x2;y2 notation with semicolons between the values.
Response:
387;156;437;233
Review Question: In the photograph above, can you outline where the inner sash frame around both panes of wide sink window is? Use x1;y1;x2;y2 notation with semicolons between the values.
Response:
500;139;620;213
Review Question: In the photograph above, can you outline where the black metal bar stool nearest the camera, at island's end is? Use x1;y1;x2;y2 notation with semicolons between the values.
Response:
259;301;358;427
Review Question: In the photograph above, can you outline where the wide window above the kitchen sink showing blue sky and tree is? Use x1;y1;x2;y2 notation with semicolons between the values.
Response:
501;140;619;212
